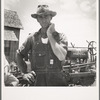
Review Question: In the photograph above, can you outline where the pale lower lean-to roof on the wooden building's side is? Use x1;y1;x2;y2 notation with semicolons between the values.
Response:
4;30;18;41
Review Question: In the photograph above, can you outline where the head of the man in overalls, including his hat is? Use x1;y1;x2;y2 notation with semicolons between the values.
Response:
31;5;56;27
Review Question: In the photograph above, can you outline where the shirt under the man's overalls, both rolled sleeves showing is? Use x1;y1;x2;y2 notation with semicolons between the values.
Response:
19;30;68;57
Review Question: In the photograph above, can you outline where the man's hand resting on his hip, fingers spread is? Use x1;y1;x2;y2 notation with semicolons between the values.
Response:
23;71;36;84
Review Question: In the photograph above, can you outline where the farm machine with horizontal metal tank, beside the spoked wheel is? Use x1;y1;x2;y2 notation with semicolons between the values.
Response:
63;47;96;86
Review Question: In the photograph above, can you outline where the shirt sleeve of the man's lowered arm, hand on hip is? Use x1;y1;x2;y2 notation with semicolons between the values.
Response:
18;35;34;57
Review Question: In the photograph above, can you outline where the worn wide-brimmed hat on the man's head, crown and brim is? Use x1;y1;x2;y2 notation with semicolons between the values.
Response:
31;5;57;18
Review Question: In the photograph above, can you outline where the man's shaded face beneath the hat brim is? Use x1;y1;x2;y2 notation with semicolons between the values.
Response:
37;15;52;28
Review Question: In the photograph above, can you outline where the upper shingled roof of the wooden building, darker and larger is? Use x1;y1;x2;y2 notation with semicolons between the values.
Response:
4;9;23;29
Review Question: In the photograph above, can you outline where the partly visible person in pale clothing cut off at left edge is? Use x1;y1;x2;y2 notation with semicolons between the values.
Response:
4;56;19;86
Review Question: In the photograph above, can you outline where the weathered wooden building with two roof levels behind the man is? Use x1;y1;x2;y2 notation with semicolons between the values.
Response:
4;9;23;63
